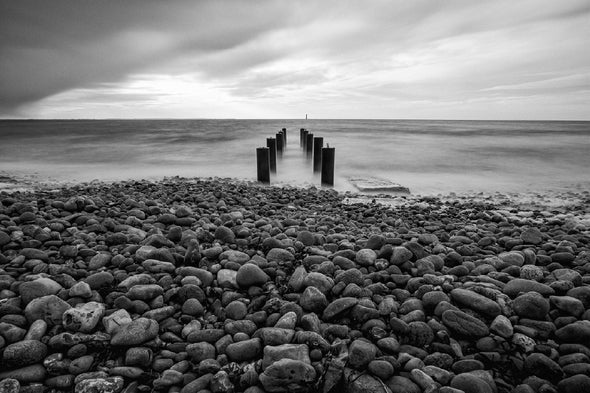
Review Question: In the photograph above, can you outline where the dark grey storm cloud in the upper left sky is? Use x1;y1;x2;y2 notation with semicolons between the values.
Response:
0;0;286;108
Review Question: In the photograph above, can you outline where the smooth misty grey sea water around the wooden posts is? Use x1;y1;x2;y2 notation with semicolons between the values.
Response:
0;119;590;194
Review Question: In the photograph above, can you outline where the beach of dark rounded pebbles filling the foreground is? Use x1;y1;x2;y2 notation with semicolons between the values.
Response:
0;178;590;393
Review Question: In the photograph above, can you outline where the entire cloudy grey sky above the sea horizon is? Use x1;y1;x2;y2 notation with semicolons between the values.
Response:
0;0;590;120
